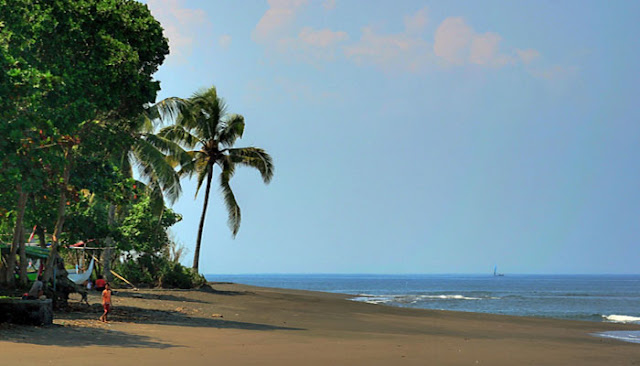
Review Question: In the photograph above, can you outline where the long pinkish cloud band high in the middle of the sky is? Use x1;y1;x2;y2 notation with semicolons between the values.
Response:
252;4;539;73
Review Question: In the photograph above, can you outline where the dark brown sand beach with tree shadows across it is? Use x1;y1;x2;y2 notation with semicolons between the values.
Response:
0;283;640;366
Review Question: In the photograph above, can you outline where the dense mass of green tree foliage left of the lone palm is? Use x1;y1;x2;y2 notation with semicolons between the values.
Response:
0;0;212;288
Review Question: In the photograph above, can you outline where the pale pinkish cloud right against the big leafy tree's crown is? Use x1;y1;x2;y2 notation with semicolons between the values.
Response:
147;0;208;63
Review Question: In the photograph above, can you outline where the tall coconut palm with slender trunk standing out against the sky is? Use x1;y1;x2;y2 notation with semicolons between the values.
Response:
159;87;273;271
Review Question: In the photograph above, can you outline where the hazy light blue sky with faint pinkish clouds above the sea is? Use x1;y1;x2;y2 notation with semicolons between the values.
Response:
146;0;640;274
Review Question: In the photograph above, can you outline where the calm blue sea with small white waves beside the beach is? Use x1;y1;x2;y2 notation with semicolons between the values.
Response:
205;274;640;324
